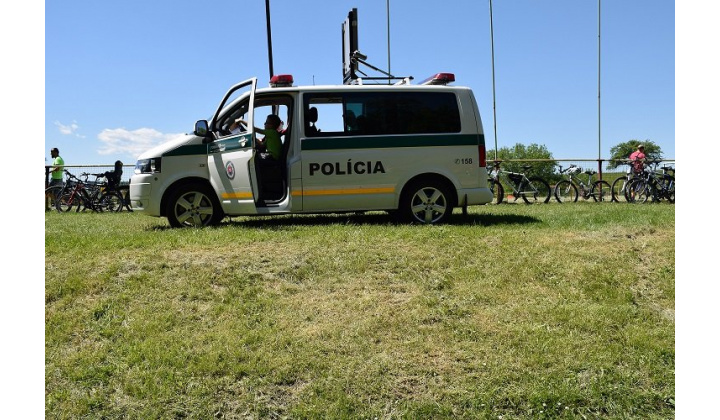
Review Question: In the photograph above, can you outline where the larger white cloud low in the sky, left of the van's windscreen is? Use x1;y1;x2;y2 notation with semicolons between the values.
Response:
98;128;184;158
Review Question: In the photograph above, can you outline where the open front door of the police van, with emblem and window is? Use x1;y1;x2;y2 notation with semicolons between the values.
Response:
208;78;259;214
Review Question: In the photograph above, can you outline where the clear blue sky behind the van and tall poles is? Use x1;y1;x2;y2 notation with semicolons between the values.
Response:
45;0;675;164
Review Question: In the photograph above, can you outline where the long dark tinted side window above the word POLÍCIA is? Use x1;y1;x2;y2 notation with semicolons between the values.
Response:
304;92;461;137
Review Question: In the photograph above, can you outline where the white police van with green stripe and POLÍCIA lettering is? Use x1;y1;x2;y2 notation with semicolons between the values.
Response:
130;73;492;227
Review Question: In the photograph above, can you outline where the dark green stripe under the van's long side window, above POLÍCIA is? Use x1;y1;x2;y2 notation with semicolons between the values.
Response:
301;134;485;150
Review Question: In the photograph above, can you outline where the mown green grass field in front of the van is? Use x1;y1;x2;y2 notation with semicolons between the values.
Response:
45;203;675;419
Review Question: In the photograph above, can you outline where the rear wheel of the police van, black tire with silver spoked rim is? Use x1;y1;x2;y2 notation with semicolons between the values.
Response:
399;178;455;224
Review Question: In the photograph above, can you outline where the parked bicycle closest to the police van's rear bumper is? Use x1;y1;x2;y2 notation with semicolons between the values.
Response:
488;162;550;204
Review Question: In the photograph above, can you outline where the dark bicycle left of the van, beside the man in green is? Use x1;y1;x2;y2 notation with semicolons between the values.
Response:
55;170;123;212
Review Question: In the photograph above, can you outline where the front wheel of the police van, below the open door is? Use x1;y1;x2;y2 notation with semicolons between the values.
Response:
165;183;225;227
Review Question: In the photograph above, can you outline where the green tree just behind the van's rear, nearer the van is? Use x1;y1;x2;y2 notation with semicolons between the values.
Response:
487;143;556;180
